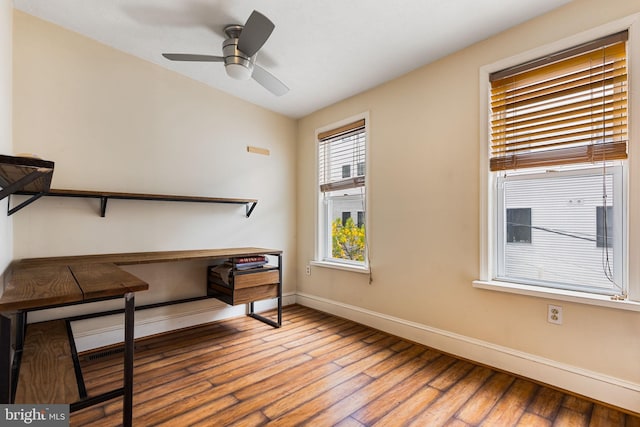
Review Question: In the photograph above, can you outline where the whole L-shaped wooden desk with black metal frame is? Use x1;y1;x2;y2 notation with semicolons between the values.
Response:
0;247;282;426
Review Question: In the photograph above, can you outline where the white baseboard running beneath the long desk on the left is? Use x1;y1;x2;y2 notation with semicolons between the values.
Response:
71;294;295;352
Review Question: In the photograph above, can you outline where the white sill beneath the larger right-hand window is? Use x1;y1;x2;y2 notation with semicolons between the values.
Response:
473;280;640;312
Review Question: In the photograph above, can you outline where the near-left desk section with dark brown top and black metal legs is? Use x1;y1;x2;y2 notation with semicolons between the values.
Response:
0;262;149;426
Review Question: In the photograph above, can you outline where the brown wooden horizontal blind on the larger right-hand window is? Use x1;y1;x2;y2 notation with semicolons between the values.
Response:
490;31;628;171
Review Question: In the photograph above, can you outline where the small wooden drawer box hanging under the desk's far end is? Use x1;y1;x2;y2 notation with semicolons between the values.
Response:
207;267;280;305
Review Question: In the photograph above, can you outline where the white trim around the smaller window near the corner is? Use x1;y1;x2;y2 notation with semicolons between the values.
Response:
310;111;371;273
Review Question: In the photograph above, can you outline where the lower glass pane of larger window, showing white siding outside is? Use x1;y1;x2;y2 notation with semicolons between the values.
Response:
498;169;622;293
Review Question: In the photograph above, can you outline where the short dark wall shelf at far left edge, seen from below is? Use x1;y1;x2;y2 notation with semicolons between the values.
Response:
0;155;54;215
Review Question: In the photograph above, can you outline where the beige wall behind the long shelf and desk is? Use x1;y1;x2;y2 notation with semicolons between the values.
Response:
13;10;296;328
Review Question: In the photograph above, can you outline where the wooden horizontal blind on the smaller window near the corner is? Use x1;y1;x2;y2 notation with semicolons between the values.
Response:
318;120;366;193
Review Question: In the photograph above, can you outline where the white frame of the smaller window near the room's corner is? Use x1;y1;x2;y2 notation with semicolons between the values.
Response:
310;112;371;273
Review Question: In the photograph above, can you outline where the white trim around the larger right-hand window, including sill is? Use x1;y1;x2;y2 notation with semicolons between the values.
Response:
473;14;640;311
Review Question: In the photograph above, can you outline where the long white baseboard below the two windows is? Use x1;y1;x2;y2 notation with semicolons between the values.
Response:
296;292;640;413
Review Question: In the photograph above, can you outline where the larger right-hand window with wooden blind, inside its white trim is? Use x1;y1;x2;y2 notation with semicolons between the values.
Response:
486;31;628;296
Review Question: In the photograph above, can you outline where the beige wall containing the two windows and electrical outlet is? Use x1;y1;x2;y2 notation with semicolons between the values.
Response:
297;0;640;410
